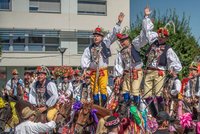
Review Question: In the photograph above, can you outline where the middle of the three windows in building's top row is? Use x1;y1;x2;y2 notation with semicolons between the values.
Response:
29;0;61;13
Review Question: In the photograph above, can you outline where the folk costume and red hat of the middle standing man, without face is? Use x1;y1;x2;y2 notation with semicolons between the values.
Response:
114;15;152;103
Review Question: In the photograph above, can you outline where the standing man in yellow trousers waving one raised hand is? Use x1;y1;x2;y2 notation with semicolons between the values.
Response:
81;13;124;105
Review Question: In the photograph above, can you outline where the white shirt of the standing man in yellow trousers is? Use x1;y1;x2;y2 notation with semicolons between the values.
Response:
81;25;121;69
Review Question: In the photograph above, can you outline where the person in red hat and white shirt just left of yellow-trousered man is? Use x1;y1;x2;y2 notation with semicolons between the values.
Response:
72;69;83;101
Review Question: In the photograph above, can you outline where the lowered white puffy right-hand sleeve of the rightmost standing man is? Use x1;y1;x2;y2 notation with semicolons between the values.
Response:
167;48;182;73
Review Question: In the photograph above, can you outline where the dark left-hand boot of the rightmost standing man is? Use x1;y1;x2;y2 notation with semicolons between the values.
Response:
145;97;158;118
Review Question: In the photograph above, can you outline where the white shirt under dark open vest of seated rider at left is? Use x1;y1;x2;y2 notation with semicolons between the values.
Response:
29;81;58;107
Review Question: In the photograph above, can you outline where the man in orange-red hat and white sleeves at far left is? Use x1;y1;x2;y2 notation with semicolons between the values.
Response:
6;69;24;97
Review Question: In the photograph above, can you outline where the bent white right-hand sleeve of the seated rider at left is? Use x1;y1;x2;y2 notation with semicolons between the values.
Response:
46;82;58;107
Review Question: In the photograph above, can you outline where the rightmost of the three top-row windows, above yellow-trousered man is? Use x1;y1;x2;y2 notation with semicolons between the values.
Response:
78;0;107;15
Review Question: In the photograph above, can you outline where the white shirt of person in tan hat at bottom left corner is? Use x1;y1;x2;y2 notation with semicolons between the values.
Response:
15;120;56;134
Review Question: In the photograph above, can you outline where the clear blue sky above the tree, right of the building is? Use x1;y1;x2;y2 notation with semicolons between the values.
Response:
130;0;200;42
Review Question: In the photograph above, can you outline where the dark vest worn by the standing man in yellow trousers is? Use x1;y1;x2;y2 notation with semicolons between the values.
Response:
89;41;111;59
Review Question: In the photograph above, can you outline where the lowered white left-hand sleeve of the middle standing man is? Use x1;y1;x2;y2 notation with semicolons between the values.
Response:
114;53;124;77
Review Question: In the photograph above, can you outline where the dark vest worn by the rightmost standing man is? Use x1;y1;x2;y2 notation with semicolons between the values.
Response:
146;41;171;66
